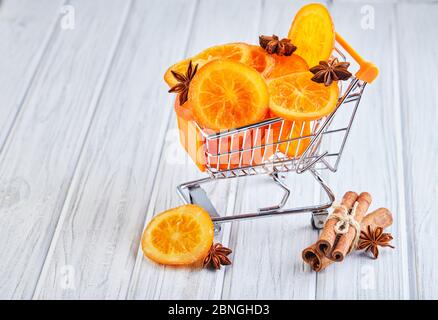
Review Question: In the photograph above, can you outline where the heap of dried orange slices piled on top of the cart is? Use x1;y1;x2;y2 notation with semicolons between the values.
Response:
164;4;339;130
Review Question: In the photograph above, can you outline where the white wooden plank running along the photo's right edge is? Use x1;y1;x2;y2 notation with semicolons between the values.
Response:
396;3;438;299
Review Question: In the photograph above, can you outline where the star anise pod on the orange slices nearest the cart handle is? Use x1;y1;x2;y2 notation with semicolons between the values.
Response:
309;58;351;86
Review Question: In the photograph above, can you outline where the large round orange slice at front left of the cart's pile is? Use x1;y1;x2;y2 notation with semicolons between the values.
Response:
189;60;269;130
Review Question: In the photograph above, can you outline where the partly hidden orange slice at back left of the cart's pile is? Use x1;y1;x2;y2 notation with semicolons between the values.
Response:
164;42;250;87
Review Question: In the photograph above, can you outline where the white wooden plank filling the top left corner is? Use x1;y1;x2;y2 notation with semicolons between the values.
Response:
0;0;62;148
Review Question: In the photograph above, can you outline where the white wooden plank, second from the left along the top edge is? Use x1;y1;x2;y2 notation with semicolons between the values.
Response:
0;0;129;298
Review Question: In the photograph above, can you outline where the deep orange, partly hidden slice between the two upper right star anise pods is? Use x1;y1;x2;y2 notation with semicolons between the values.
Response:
263;54;309;79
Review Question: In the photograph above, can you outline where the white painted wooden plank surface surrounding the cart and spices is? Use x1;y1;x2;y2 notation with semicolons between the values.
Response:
0;0;438;299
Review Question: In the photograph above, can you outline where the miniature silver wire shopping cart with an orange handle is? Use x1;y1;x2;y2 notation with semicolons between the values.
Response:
177;34;378;231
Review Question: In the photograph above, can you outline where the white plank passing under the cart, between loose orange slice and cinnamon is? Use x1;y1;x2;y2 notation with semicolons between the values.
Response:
222;0;321;299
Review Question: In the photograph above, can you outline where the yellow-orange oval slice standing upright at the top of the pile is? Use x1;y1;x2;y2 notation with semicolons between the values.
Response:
288;3;335;67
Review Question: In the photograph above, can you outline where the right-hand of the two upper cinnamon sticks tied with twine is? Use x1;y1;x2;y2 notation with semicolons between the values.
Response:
328;192;372;262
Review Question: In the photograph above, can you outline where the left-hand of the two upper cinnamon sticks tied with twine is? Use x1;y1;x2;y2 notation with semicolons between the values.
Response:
316;191;357;257
